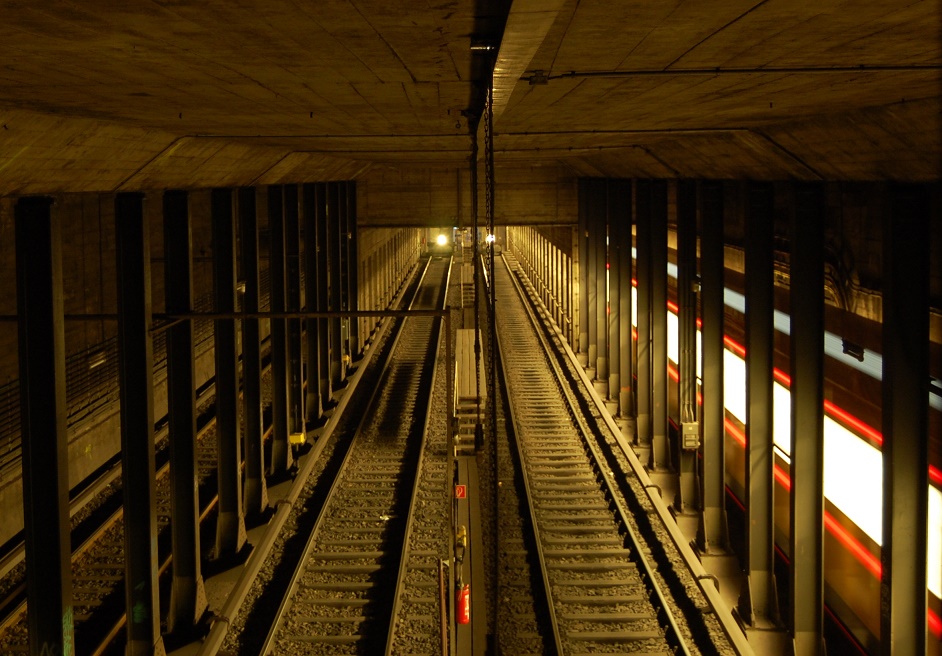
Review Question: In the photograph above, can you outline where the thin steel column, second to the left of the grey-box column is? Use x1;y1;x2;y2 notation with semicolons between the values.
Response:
635;180;653;446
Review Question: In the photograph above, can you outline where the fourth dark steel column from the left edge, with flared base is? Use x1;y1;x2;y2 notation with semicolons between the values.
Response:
210;189;246;559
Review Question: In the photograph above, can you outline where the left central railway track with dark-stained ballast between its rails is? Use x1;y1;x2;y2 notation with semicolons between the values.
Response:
261;258;449;654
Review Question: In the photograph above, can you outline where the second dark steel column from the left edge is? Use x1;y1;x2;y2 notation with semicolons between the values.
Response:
115;193;164;656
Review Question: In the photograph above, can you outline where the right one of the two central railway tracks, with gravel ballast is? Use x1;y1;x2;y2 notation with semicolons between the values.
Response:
495;254;690;655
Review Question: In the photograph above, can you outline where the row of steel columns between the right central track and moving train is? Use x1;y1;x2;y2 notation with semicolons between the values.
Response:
510;179;930;654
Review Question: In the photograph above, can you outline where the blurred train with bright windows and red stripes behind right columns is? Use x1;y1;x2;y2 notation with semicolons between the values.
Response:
656;264;942;654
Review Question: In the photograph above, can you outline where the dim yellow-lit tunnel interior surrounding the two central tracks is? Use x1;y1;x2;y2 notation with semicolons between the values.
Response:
0;0;942;654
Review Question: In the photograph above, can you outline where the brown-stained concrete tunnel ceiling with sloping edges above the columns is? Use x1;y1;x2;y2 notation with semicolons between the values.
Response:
0;0;942;194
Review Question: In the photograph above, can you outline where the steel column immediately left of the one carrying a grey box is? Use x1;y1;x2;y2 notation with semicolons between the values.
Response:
648;180;673;470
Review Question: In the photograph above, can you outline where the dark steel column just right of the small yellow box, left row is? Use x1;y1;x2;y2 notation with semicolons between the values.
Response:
301;183;328;421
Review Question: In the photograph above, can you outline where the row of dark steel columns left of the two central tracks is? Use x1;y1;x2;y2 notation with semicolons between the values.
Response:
15;182;384;654
